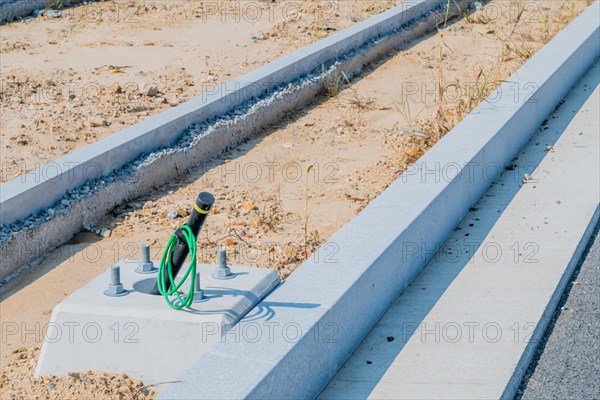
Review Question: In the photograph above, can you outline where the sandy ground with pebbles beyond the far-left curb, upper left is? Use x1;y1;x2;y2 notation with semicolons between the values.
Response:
0;0;395;182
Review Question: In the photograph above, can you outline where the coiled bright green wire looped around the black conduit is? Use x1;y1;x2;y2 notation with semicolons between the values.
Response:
157;225;196;310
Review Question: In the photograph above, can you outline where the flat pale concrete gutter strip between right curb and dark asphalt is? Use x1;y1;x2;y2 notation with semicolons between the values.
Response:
320;64;600;399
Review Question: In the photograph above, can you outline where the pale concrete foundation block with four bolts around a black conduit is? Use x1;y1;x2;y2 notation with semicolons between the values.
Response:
35;260;280;384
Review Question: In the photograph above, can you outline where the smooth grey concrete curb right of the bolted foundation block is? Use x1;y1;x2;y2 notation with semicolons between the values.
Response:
159;2;600;399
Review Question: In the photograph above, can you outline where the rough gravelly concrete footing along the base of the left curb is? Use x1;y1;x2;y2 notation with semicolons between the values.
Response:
0;1;467;281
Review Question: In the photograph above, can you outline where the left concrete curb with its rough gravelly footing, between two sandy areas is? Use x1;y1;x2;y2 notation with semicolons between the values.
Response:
0;0;468;281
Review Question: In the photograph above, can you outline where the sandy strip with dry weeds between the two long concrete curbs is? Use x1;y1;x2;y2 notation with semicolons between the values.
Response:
0;1;588;397
